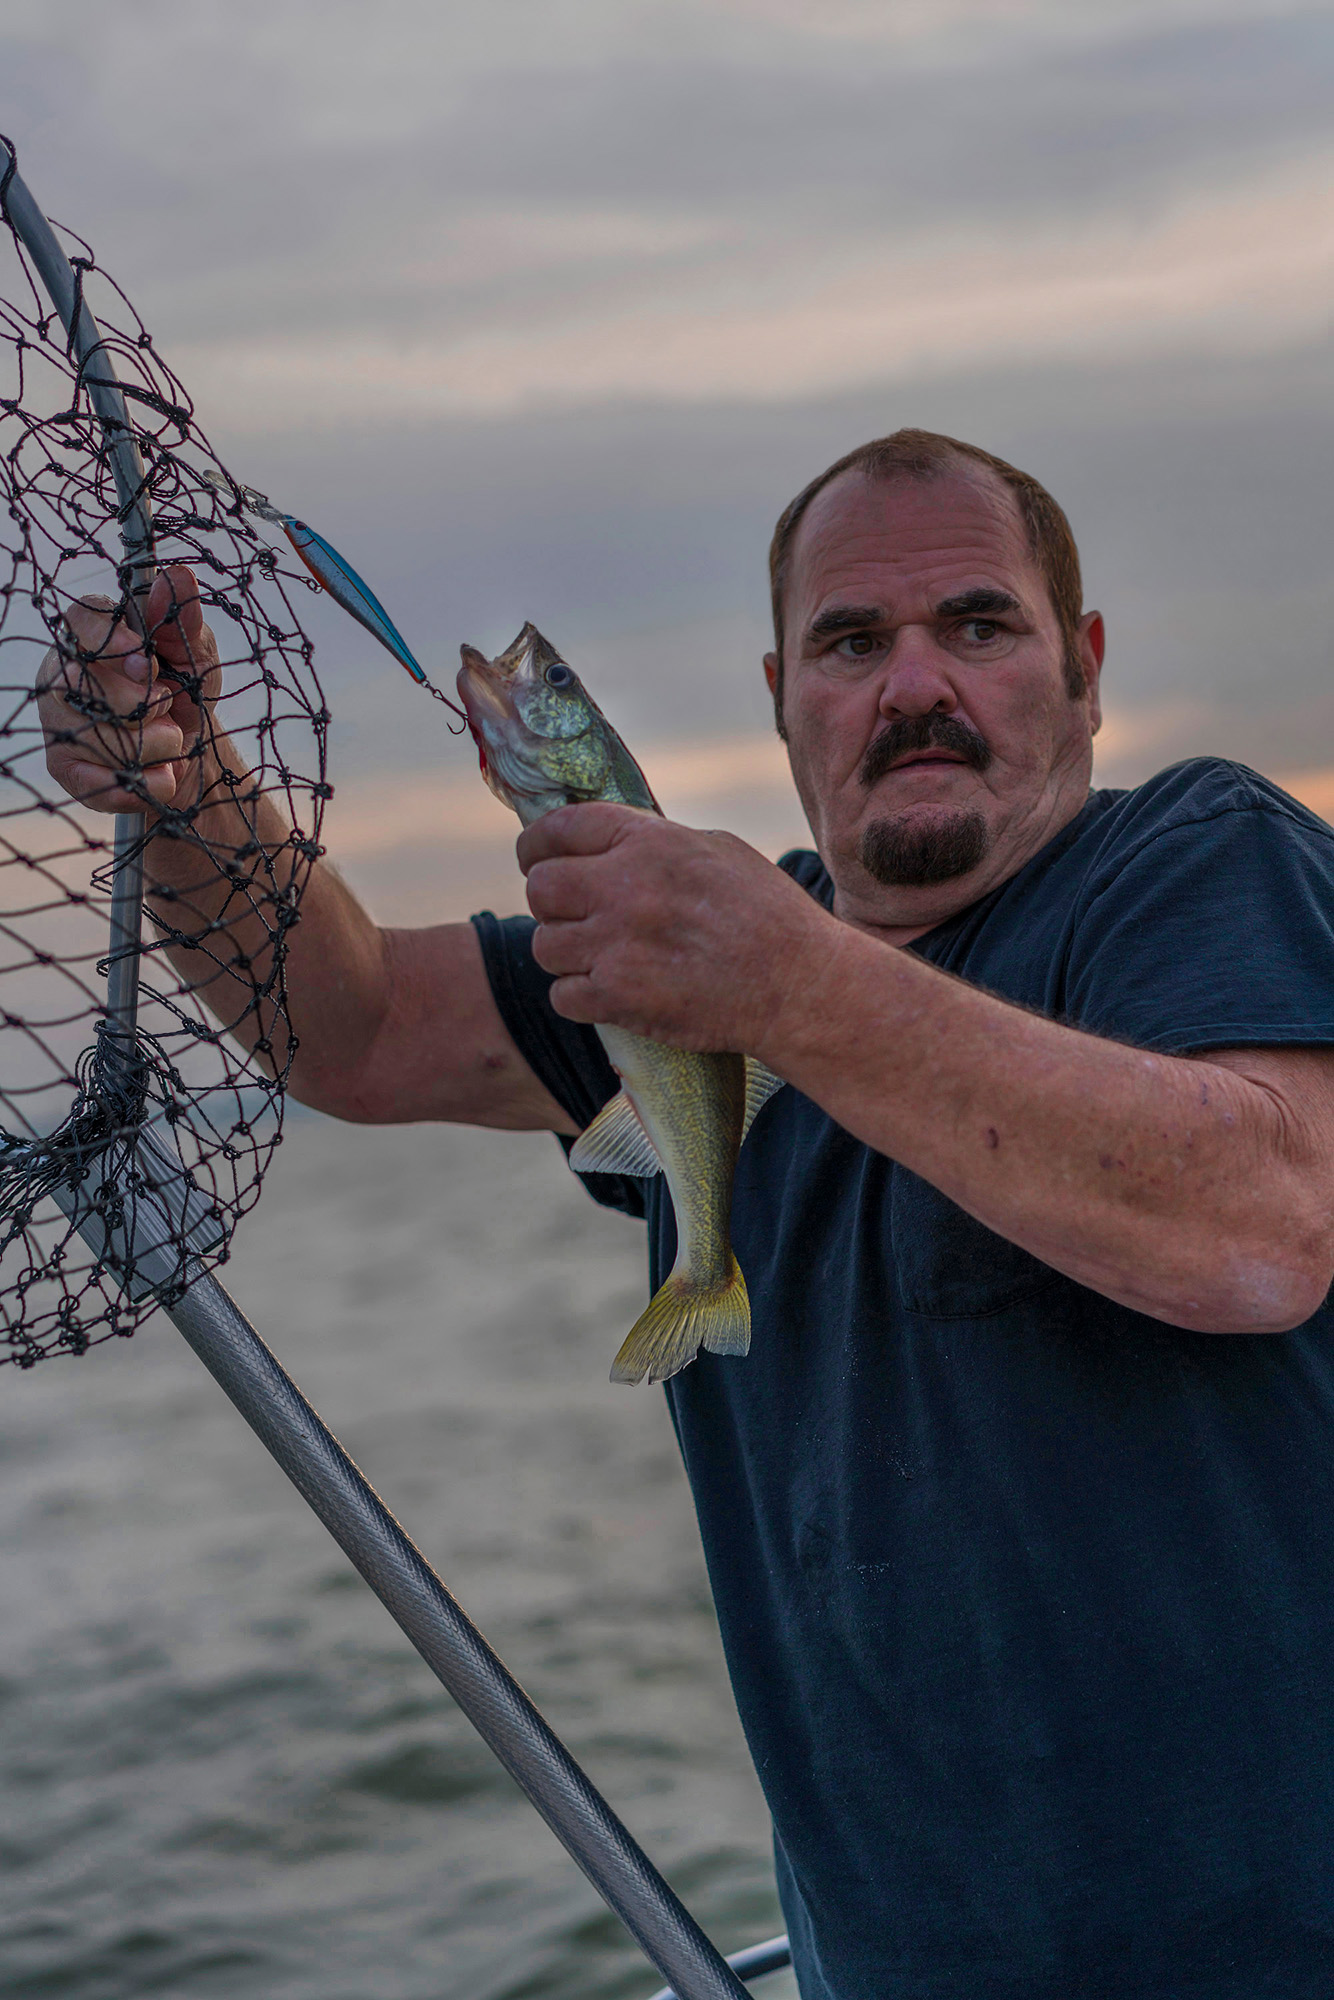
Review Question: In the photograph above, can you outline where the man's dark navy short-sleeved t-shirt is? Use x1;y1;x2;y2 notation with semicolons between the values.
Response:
478;760;1334;2000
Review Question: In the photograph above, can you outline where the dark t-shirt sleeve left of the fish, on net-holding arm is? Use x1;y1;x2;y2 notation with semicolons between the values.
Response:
472;910;644;1216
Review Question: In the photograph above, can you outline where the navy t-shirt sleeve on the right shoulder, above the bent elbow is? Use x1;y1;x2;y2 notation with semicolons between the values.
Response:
1066;780;1334;1054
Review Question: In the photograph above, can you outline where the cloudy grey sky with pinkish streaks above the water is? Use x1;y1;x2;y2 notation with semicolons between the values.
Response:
0;0;1334;922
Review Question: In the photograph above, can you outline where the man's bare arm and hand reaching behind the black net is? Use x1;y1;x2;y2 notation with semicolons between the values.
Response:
42;568;578;1132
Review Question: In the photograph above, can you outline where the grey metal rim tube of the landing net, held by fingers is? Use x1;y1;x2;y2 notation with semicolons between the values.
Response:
0;134;158;1042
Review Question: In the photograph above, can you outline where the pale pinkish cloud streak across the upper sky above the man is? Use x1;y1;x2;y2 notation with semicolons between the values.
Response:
164;156;1334;428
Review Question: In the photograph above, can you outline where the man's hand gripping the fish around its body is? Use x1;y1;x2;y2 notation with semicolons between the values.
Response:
518;804;844;1056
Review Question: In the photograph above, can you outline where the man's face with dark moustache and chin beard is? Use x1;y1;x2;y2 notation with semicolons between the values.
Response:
766;466;1102;934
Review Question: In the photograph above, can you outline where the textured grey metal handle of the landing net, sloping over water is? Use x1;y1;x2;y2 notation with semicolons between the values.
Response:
166;1276;746;2000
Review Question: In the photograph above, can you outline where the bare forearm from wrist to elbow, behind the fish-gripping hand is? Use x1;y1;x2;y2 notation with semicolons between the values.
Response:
756;920;1334;1332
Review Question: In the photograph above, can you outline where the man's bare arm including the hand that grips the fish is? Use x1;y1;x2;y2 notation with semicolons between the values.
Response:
520;806;1334;1334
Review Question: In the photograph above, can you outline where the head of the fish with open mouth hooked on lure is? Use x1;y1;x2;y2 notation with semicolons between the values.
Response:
458;624;658;826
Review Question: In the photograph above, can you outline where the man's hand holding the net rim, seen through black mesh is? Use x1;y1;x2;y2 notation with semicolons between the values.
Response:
38;564;222;812
